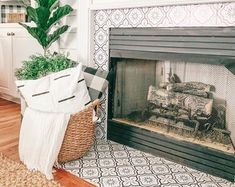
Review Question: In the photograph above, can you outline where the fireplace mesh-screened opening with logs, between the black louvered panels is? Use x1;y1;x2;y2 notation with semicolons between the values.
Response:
113;59;235;153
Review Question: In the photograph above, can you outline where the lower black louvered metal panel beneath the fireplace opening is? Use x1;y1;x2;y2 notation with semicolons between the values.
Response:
108;120;235;182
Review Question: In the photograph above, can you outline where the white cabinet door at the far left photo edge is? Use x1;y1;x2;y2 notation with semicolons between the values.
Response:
0;32;12;94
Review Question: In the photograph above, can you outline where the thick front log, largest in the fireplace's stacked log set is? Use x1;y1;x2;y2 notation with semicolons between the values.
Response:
147;86;213;116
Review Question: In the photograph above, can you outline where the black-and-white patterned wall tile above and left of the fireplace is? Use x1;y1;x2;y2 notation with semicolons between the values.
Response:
94;2;235;138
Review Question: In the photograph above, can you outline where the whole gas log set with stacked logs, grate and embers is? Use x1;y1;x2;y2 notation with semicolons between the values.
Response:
128;75;231;145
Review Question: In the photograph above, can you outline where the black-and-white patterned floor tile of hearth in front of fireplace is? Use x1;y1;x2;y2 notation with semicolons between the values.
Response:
63;140;235;187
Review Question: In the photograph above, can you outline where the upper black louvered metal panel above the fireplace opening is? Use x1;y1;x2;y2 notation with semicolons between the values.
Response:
109;27;235;74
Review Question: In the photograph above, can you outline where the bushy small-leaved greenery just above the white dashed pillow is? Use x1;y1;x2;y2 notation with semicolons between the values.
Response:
15;54;75;80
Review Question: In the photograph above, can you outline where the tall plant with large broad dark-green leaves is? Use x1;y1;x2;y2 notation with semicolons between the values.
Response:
20;0;73;55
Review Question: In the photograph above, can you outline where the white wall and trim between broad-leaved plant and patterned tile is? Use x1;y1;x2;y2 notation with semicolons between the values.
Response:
60;0;94;66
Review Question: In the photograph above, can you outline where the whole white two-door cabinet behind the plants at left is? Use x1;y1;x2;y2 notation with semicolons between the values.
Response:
0;28;43;98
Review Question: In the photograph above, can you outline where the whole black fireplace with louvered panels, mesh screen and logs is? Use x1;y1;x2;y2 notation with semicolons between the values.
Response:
108;27;235;181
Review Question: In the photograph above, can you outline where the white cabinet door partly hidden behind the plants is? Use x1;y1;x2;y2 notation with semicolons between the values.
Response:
11;30;43;97
